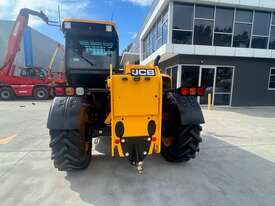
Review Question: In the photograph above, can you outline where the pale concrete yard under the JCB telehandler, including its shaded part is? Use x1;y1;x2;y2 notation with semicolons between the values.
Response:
0;101;275;206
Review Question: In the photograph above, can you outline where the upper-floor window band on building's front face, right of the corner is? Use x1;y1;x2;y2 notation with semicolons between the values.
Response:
169;2;275;50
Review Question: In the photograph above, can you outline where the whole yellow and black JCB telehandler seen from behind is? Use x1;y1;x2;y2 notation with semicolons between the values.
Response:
47;19;204;171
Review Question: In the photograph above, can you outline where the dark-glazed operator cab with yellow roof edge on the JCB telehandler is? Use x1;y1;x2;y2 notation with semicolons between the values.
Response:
62;19;119;88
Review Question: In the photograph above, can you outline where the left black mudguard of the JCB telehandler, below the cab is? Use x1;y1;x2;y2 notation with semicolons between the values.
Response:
47;97;82;130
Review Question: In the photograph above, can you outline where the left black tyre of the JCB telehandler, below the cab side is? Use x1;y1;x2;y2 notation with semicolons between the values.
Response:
50;130;92;171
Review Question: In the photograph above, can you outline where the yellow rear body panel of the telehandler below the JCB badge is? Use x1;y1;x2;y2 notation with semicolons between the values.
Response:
108;65;162;157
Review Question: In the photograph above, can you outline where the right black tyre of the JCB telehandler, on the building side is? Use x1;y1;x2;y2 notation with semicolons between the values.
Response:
161;125;202;162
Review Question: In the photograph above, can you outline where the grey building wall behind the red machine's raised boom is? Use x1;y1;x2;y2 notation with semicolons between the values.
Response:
0;20;64;74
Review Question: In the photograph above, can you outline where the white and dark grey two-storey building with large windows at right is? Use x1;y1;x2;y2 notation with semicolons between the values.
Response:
122;0;275;106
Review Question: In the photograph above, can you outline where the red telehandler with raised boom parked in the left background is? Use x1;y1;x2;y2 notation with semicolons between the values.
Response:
0;8;65;100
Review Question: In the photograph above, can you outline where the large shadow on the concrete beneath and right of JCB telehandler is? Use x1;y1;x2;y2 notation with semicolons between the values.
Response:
66;136;275;206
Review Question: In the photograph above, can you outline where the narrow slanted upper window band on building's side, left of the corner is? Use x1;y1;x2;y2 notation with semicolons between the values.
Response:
143;8;168;59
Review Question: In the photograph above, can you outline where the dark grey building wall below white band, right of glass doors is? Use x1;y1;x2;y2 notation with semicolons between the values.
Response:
160;55;275;106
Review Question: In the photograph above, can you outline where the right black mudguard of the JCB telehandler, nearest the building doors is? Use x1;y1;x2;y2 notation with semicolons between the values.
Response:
172;94;205;125
